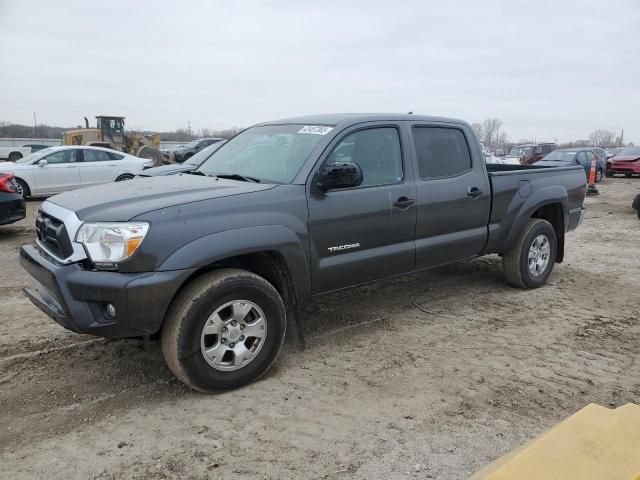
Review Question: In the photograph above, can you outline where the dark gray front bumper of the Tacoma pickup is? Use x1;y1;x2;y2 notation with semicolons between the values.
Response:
20;245;194;337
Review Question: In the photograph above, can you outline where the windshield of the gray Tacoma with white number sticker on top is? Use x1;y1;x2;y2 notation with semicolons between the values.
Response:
198;124;332;183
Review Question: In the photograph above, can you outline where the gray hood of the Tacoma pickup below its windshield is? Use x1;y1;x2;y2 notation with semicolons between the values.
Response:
48;175;276;222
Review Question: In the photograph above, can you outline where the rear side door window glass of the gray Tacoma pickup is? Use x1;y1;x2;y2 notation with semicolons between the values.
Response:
413;127;471;178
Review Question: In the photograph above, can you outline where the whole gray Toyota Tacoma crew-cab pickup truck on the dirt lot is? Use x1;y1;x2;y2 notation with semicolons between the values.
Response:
20;114;586;392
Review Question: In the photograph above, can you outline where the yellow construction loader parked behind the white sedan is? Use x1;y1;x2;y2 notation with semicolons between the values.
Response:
62;115;167;166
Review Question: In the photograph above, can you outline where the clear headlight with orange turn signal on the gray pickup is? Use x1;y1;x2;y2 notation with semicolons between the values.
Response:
76;222;149;266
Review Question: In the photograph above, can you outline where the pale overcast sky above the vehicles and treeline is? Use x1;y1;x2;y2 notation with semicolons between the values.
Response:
0;0;640;143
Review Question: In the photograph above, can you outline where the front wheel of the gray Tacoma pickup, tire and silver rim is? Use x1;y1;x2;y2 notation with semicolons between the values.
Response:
161;269;286;392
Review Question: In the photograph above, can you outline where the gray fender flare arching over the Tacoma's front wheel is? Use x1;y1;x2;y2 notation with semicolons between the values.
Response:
158;225;311;302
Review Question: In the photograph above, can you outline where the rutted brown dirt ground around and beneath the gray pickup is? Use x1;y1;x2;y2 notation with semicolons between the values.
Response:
0;178;640;479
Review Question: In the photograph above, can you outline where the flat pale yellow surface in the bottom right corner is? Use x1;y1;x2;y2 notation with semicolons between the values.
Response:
471;403;640;480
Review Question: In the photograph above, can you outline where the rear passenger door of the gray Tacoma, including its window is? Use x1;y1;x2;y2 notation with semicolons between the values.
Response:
411;123;491;268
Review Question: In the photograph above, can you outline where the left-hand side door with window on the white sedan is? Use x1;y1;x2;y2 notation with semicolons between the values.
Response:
33;148;80;194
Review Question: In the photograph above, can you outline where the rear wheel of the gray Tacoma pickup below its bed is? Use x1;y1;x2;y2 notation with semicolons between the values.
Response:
502;218;557;289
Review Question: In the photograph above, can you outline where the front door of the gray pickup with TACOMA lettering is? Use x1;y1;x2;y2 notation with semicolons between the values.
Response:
308;124;416;293
